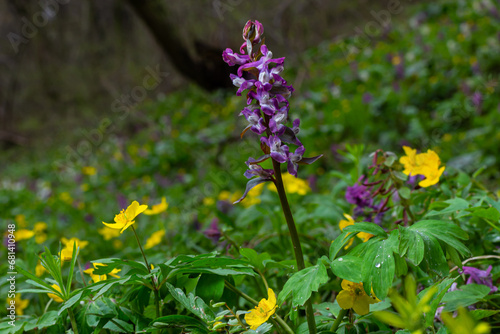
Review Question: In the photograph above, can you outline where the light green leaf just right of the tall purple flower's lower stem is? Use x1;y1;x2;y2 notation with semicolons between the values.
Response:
278;261;328;307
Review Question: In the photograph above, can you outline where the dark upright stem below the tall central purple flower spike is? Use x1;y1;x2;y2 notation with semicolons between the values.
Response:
272;159;316;334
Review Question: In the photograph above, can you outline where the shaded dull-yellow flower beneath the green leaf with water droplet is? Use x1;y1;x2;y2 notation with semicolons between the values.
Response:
337;280;380;315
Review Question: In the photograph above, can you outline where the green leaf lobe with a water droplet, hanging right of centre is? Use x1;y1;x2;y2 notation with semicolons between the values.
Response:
362;230;398;299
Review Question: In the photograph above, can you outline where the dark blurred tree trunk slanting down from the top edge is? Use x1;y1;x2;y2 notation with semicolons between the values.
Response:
128;0;232;91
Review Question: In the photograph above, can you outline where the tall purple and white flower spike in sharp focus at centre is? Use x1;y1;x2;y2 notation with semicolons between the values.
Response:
222;21;320;201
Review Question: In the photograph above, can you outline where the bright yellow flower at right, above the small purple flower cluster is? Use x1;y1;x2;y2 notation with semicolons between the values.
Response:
399;146;445;188
